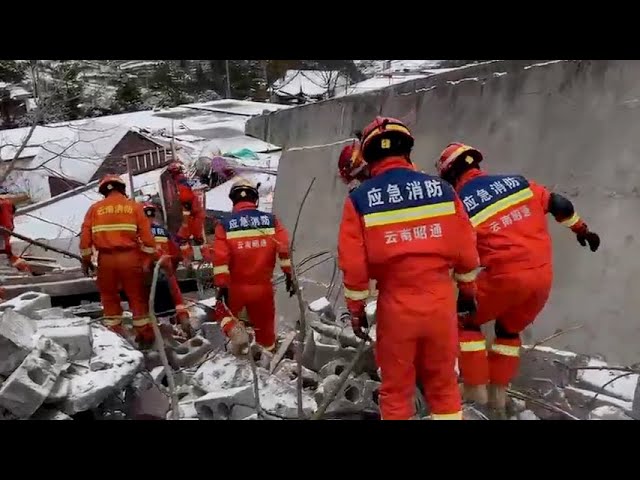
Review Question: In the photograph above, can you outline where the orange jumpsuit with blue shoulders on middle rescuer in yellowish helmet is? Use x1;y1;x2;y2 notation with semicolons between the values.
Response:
213;202;291;350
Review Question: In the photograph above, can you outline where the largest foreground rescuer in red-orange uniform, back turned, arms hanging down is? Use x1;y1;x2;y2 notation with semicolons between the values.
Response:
338;117;479;420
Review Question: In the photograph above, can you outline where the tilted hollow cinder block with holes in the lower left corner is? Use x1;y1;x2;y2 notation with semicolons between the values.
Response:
0;337;68;418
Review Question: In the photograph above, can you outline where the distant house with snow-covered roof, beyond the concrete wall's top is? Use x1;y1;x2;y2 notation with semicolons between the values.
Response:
271;70;348;104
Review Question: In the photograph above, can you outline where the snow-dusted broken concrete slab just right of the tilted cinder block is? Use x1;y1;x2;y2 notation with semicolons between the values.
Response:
61;324;143;415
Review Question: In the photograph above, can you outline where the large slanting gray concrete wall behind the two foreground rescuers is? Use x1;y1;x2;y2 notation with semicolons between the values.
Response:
247;61;640;363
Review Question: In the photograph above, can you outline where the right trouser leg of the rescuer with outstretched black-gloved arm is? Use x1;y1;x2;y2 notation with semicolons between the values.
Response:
489;267;553;386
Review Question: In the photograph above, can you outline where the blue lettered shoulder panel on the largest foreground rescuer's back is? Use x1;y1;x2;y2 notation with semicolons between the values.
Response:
349;168;455;215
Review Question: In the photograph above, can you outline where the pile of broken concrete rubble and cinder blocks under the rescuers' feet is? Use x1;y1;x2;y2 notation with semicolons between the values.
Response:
0;292;640;420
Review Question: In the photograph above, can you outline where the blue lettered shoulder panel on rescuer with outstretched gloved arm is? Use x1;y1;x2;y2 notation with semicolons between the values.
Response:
460;175;529;217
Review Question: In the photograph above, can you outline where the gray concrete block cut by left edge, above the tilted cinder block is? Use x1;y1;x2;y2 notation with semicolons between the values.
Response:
0;310;36;376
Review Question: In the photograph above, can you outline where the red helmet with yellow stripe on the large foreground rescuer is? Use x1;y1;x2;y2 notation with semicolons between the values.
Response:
361;117;414;162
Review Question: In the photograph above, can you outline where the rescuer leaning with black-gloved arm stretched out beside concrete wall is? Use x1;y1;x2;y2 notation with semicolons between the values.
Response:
436;143;600;417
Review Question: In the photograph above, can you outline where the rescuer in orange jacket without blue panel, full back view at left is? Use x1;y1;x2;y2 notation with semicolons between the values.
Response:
80;175;156;346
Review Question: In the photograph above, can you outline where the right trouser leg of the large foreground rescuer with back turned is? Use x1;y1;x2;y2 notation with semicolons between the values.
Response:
416;310;462;420
